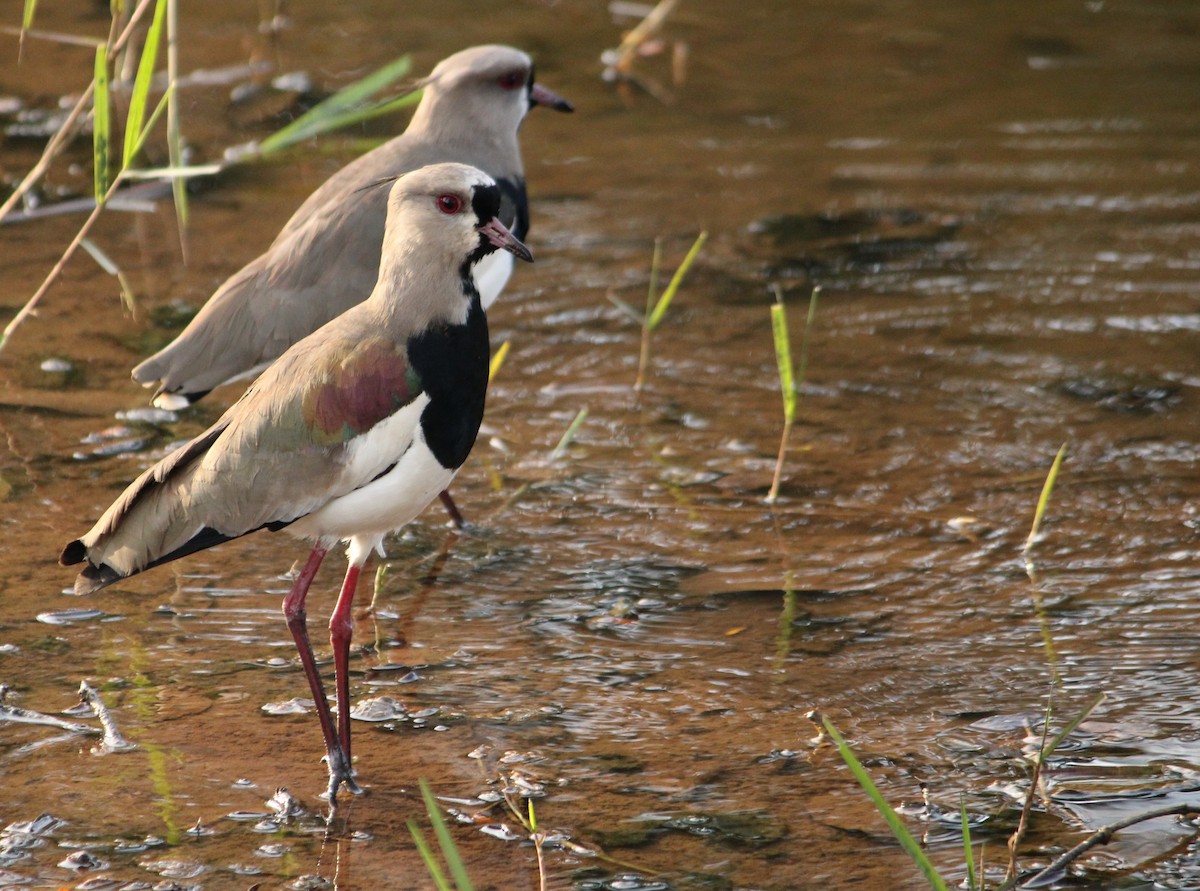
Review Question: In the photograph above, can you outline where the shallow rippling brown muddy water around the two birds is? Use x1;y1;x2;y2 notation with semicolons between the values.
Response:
0;0;1200;890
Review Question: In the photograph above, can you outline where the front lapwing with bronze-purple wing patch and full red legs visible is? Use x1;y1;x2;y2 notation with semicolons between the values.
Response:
59;163;533;809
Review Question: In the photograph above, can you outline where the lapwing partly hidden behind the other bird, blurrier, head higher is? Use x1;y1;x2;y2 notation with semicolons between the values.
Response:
133;46;572;408
